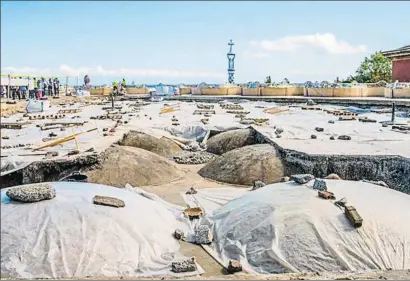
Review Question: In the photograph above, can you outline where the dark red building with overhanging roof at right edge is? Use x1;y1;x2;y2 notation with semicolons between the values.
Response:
382;45;410;82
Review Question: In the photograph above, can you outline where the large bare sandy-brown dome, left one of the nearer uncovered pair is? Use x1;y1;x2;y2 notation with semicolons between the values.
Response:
86;146;184;187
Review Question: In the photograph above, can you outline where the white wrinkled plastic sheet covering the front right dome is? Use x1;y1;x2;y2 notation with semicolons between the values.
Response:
184;180;410;274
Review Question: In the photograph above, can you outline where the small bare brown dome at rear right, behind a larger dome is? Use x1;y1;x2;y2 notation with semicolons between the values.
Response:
207;128;255;155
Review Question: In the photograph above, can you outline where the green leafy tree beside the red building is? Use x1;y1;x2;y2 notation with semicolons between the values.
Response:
348;52;392;83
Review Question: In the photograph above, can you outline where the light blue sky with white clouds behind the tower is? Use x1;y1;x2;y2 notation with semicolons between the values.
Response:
1;1;410;84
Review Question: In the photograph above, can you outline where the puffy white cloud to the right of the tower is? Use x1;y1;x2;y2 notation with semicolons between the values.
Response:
250;33;367;54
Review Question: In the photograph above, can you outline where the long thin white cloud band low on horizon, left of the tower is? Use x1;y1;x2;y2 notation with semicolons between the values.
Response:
2;64;225;78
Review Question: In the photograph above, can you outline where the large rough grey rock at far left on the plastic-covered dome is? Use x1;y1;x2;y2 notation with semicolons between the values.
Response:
6;183;56;203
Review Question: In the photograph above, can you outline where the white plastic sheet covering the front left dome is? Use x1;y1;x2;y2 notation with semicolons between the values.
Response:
1;182;203;279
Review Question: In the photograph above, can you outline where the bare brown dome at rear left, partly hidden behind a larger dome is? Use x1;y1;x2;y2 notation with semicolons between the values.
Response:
119;131;182;157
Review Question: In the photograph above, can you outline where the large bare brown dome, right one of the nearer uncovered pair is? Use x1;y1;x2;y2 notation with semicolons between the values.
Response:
199;144;284;185
